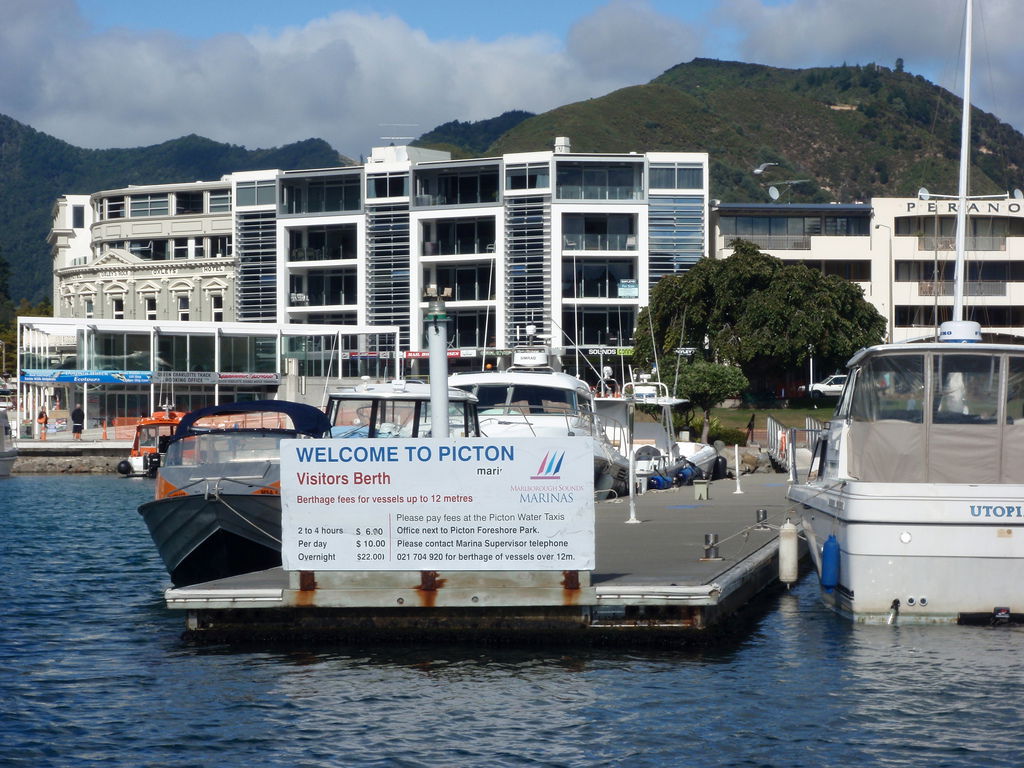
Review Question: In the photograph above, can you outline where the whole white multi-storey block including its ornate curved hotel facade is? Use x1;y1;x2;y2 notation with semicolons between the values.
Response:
50;139;710;366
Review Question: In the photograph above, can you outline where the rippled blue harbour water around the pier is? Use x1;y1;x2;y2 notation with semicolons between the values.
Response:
0;475;1024;768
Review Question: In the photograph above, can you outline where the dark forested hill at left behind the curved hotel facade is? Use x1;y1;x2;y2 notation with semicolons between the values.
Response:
0;115;351;303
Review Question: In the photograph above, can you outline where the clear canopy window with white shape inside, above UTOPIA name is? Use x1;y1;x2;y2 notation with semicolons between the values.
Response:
932;354;999;424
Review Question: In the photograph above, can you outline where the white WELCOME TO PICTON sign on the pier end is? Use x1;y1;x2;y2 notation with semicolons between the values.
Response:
281;437;594;570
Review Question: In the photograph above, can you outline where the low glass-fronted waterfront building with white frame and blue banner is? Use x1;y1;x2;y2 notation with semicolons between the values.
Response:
17;317;397;436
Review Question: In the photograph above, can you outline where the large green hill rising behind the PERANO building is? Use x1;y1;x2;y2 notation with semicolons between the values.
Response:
464;58;1024;203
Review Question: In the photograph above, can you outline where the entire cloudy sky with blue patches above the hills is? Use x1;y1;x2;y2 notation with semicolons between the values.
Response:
0;0;1024;158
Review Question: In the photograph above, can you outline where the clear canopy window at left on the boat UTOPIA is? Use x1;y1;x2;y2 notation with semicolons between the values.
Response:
850;354;925;424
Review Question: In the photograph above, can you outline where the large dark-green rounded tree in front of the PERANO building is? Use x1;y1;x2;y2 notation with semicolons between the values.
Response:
635;240;886;391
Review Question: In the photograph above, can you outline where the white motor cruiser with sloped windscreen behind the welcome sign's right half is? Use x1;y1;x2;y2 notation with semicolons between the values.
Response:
449;348;629;499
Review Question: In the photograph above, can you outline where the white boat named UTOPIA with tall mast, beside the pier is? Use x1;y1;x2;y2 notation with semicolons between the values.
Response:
788;2;1024;623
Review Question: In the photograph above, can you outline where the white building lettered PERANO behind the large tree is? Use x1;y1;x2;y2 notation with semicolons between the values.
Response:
713;196;1024;341
